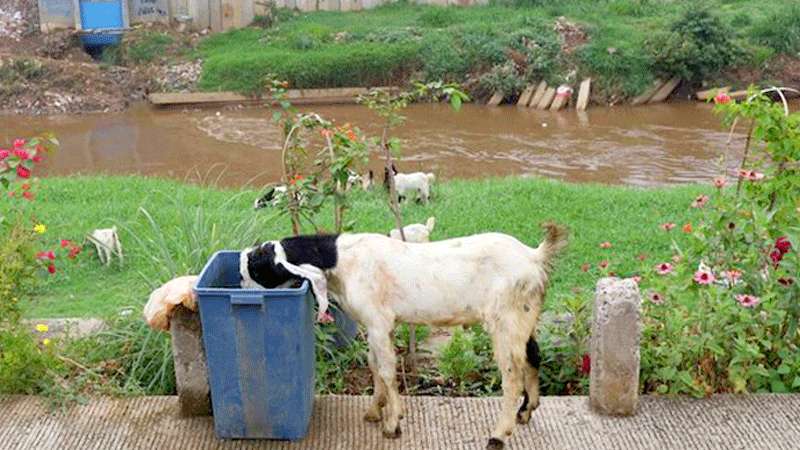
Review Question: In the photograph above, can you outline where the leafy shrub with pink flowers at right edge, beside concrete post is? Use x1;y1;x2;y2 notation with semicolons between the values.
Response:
640;92;800;396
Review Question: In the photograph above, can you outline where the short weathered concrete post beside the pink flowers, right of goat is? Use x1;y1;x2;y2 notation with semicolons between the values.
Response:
589;278;642;416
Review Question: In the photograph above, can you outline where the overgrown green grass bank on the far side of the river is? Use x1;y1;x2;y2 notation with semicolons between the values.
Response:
199;0;800;101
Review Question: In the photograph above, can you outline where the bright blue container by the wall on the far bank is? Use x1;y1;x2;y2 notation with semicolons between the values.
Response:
78;0;125;47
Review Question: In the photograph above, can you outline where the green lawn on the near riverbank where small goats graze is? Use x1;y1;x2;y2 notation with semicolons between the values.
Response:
24;176;701;317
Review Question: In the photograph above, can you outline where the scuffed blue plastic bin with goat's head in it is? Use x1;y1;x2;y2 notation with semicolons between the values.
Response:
195;251;315;440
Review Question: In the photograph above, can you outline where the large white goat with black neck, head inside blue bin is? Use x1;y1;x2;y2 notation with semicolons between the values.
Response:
240;224;566;448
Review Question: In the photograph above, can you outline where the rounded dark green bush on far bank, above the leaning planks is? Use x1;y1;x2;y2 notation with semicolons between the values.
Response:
647;4;742;83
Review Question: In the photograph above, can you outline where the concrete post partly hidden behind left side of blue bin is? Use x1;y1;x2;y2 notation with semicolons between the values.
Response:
170;305;211;417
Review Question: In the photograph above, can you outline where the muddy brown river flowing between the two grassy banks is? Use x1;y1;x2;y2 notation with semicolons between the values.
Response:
0;102;742;186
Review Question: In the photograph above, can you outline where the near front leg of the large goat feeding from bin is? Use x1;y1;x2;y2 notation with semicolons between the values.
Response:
367;330;402;439
